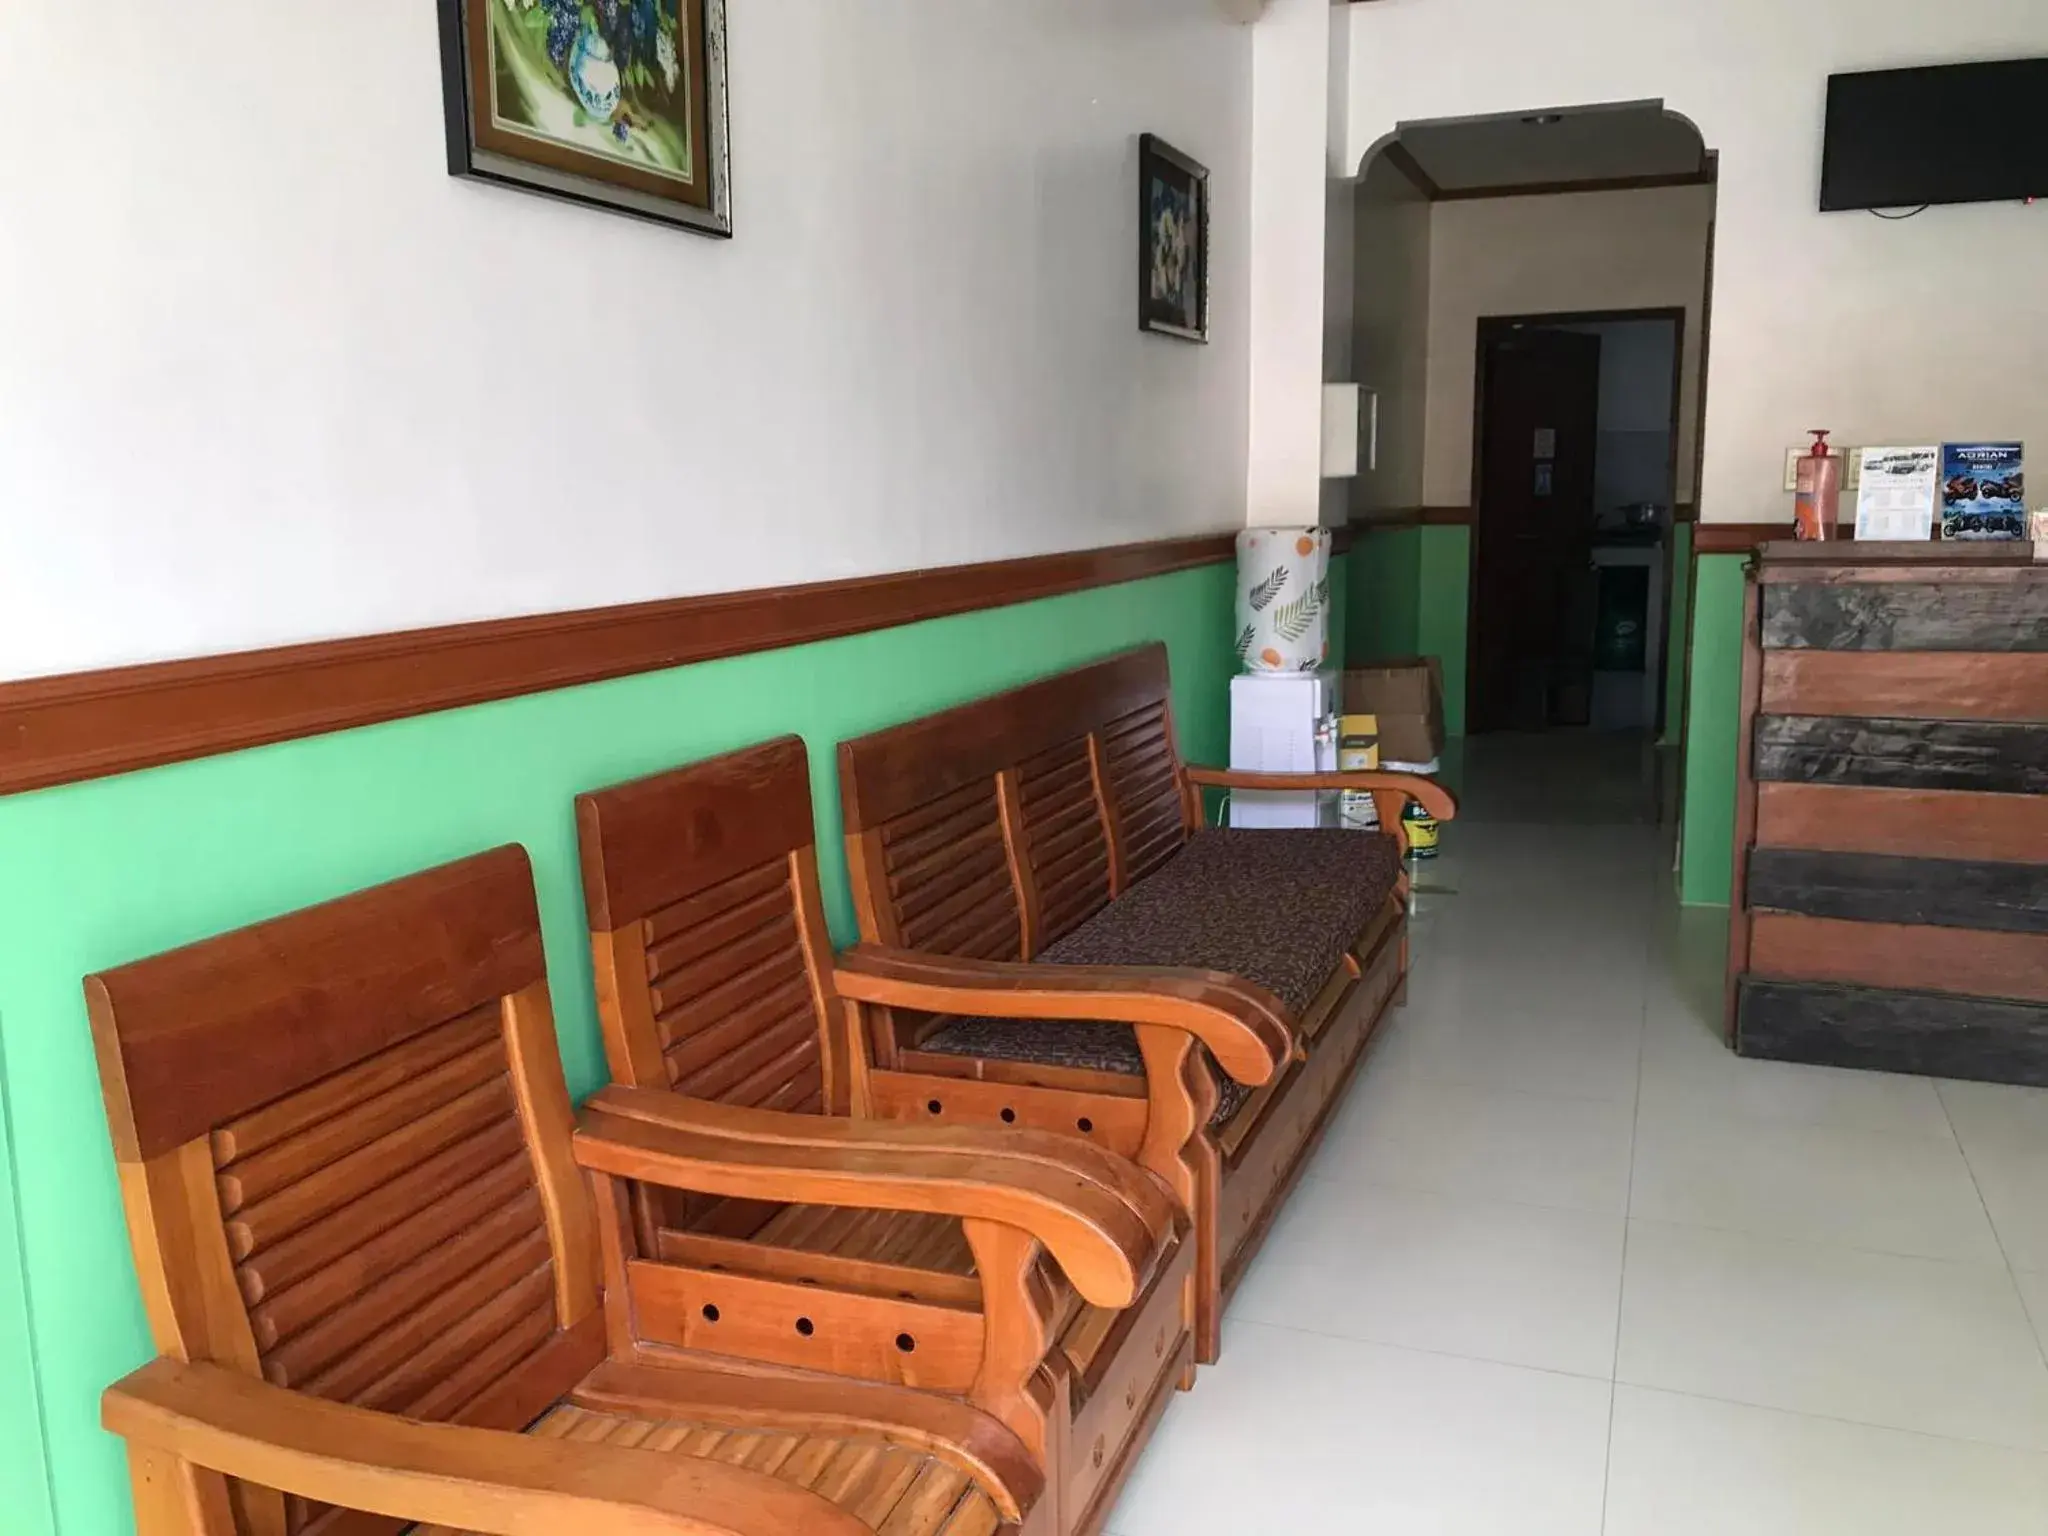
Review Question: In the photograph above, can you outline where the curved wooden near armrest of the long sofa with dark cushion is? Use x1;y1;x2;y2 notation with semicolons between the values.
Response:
834;944;1294;1087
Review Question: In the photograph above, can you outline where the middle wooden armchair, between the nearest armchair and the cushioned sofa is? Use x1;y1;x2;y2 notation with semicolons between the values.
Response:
578;737;1196;1532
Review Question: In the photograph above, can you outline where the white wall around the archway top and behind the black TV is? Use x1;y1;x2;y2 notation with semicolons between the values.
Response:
1350;0;2048;522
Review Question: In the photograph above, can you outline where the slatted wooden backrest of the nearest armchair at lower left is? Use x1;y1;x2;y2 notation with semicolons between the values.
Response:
86;848;604;1536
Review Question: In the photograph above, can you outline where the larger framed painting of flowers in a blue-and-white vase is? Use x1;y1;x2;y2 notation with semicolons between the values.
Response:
440;0;733;236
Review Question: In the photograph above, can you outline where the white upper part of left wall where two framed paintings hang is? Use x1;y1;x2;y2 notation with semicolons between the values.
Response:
0;0;1253;678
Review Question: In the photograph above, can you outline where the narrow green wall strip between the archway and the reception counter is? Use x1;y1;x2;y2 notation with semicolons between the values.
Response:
1679;555;1745;905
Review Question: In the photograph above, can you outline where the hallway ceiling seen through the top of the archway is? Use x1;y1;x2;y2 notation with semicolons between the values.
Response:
1399;102;1704;193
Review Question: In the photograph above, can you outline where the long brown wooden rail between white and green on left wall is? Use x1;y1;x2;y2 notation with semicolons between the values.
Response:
0;530;1245;795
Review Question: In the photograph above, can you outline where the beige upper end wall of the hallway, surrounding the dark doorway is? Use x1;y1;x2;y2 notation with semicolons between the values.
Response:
1423;186;1712;505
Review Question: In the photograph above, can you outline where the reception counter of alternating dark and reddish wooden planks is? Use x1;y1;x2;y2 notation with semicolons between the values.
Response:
1729;543;2048;1085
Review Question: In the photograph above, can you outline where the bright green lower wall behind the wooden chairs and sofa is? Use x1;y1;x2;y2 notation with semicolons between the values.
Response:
0;563;1233;1536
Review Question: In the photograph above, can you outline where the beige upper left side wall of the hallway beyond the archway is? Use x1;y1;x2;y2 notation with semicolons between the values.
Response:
1352;158;1433;516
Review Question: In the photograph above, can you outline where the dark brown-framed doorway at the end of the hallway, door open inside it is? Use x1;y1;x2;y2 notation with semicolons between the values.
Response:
1466;309;1686;731
